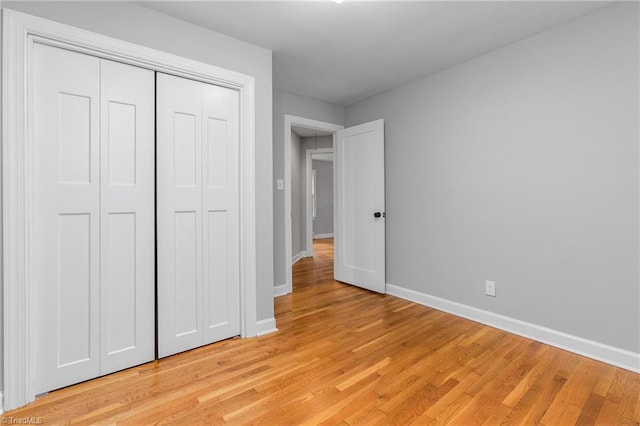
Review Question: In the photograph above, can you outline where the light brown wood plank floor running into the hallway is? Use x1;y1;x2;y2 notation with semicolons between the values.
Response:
2;239;640;425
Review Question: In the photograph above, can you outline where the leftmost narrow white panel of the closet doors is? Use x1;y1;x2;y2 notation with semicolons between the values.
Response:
32;44;100;393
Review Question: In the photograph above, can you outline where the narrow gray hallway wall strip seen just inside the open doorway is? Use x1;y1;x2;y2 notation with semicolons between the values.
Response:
291;130;306;257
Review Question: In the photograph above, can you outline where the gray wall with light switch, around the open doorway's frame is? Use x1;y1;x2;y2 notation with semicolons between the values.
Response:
273;90;344;285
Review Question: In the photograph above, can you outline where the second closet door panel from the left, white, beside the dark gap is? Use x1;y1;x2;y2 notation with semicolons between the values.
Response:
100;60;155;374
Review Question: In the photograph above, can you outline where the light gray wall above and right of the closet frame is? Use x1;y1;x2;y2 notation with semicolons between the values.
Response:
3;1;273;328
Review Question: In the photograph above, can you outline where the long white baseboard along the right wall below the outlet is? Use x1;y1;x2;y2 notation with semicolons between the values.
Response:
387;284;640;373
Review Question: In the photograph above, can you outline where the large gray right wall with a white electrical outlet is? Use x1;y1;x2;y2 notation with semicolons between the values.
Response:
346;3;640;352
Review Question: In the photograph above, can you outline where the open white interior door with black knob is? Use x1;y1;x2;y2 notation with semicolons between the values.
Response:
334;120;385;293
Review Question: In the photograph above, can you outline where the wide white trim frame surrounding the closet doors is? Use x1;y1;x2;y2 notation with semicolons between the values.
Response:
2;9;257;411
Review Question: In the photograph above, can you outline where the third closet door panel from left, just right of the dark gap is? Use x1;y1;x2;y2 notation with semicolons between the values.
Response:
156;73;203;357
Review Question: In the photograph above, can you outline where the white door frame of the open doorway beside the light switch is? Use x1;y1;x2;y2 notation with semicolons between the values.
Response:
284;114;344;296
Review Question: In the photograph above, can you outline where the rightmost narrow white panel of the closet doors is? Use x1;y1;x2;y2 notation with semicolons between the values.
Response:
202;84;240;343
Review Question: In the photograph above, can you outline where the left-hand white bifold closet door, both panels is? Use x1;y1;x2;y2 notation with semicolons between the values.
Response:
30;44;154;393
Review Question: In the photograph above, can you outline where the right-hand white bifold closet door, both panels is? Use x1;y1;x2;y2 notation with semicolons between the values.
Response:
156;74;240;357
